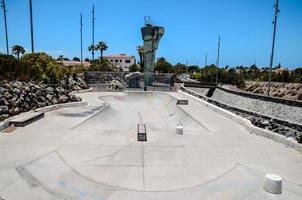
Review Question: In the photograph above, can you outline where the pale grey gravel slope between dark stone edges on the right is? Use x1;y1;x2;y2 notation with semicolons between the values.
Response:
210;88;302;124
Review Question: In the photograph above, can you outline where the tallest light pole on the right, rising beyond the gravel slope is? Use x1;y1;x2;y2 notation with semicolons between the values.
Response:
267;0;280;96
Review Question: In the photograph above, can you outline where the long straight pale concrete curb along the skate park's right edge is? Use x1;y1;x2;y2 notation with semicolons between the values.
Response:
178;90;302;153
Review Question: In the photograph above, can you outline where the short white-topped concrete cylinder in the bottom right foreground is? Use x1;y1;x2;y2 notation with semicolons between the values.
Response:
263;174;282;194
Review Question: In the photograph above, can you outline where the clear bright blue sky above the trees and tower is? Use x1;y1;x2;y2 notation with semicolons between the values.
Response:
0;0;302;69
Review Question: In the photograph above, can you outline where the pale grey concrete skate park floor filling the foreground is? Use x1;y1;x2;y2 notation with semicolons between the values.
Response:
0;91;302;200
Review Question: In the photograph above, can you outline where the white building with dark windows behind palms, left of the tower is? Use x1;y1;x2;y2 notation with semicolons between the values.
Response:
104;54;136;72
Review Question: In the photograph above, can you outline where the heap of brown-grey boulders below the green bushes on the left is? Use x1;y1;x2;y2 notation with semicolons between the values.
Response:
0;77;87;121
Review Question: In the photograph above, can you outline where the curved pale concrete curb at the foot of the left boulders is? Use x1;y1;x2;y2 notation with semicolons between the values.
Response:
0;101;88;131
